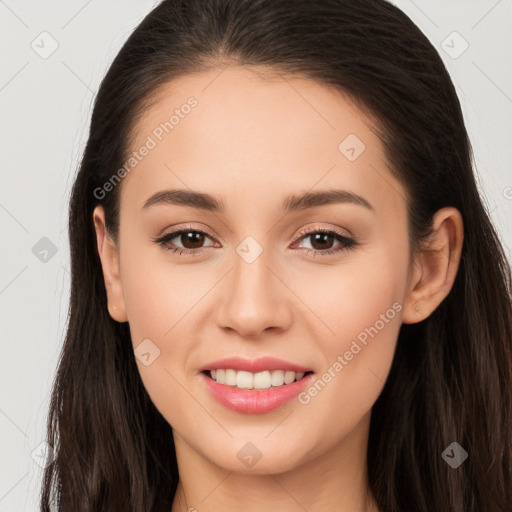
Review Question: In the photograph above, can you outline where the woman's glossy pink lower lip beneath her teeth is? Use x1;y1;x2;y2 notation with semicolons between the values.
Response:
201;373;315;414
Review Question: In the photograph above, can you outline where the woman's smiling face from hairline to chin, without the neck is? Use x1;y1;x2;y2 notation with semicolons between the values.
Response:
97;67;416;473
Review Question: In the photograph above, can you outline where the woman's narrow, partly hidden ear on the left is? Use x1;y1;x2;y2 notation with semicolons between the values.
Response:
93;206;128;322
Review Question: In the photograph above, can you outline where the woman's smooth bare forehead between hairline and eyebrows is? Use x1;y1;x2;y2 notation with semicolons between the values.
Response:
122;66;400;216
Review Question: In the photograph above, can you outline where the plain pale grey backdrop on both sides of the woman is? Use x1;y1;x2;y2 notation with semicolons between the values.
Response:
0;0;512;512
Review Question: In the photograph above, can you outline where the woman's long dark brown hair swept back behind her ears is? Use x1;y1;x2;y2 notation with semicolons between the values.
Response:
41;0;512;512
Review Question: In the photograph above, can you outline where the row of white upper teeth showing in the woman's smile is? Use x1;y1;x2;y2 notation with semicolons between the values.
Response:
210;369;304;389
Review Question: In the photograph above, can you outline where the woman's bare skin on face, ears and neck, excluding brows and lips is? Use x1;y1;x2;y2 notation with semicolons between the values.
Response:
93;65;463;512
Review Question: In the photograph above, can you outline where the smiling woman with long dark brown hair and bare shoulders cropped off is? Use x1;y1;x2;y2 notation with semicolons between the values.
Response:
42;0;512;512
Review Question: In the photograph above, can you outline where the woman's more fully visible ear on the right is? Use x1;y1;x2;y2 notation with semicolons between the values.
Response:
402;207;464;324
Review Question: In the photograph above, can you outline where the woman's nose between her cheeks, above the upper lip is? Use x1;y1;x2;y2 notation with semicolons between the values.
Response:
216;245;292;338
